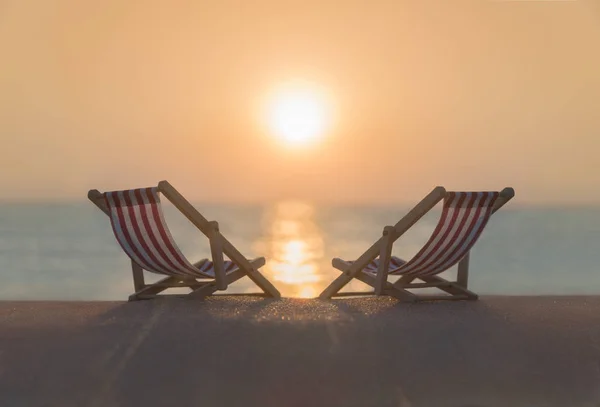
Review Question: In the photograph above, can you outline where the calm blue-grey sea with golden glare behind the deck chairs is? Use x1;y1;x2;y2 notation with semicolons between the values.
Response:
0;201;600;300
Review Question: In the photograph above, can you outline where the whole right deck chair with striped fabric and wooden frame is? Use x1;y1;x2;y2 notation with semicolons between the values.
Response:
320;187;515;302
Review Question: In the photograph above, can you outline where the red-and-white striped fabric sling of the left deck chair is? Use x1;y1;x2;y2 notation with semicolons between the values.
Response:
104;187;237;278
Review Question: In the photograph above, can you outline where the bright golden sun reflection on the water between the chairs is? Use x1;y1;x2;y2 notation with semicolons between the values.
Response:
255;201;323;298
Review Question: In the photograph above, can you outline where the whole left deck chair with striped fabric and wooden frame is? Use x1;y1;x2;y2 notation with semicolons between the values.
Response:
88;181;280;301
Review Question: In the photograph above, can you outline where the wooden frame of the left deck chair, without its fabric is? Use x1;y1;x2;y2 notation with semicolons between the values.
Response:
88;181;281;301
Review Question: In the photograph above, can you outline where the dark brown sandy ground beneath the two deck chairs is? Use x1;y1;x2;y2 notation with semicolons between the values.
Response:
0;297;600;407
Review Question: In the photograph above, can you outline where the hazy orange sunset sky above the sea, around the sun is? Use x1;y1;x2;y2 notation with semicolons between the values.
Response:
0;0;600;205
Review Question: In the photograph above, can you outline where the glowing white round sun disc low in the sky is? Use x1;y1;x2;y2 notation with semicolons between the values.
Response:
267;84;331;146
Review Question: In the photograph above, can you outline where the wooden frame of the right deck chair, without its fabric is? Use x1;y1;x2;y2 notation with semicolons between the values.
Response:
319;186;515;302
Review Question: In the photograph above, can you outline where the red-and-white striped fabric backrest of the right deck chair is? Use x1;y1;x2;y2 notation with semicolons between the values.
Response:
393;192;499;276
